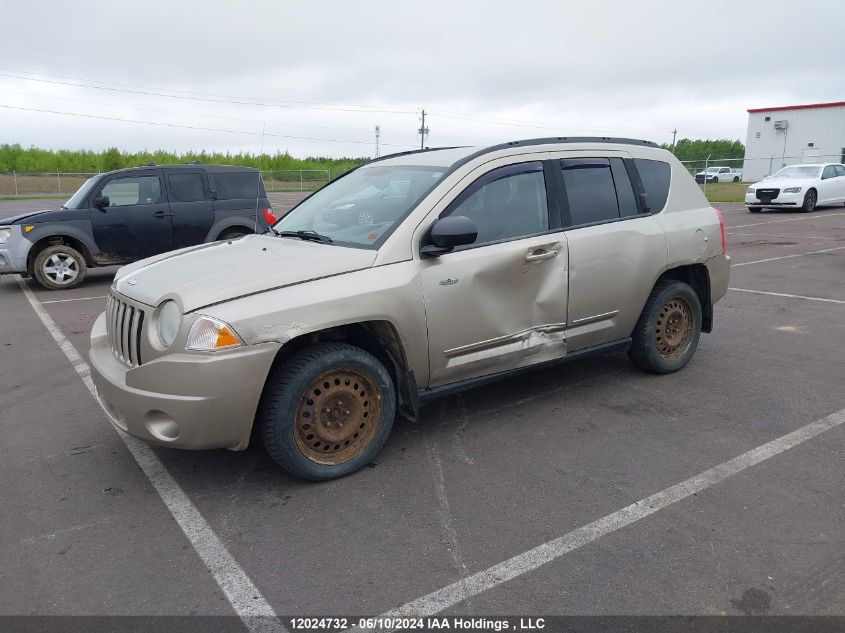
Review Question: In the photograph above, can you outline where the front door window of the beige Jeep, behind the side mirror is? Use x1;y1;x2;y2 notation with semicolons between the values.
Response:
441;162;549;244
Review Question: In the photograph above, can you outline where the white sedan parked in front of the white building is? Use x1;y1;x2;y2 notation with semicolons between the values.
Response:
745;163;845;213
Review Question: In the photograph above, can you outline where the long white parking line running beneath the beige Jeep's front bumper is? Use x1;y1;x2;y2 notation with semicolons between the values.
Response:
17;279;285;633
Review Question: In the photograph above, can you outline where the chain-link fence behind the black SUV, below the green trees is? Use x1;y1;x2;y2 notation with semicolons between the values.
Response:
0;169;340;197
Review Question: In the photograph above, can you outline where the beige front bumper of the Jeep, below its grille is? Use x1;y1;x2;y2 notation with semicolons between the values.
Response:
89;313;280;450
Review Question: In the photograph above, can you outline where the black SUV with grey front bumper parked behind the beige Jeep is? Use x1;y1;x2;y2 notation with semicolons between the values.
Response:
0;164;276;290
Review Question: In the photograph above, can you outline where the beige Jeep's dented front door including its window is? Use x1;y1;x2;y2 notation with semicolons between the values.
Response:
420;155;568;387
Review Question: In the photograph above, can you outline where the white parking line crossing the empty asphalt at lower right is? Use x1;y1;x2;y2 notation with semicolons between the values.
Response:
372;409;845;618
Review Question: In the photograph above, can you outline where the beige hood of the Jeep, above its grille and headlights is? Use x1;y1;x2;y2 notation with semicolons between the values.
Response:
114;235;377;313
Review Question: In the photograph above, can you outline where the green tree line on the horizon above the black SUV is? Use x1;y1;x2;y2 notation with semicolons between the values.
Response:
0;144;369;175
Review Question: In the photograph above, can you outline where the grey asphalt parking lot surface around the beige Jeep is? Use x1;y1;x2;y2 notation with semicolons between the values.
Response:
0;194;845;616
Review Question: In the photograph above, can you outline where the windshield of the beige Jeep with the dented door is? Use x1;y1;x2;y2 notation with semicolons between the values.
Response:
273;164;446;247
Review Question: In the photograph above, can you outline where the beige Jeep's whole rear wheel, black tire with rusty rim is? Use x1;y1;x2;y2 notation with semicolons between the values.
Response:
628;279;701;374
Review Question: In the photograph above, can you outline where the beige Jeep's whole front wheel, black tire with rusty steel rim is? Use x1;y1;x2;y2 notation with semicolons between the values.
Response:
256;343;396;481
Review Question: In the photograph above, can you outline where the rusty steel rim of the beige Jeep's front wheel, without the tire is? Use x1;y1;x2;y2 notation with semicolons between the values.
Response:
294;369;382;466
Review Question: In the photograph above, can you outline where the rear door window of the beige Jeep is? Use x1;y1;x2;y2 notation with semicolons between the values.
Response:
560;158;620;226
